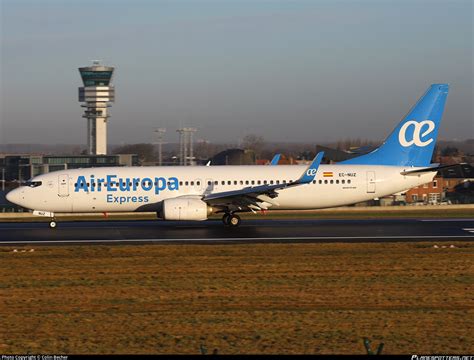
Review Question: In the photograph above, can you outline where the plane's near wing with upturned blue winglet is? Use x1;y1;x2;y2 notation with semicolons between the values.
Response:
202;152;324;211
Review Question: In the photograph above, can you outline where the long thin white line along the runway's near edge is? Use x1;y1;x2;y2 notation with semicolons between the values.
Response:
0;235;474;245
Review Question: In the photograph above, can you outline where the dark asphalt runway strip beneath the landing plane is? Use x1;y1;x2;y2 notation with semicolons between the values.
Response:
0;219;474;246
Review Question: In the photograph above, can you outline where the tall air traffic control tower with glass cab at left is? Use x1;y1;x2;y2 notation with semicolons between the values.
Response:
79;61;115;155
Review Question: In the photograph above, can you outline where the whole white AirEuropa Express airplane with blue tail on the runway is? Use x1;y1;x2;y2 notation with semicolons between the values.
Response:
7;84;448;228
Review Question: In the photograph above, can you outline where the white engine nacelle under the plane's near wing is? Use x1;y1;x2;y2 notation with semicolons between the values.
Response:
160;198;212;221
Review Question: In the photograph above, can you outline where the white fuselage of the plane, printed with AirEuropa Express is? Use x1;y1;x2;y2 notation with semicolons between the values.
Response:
9;165;436;213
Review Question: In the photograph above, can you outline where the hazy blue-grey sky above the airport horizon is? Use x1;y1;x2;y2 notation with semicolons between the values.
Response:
0;0;474;144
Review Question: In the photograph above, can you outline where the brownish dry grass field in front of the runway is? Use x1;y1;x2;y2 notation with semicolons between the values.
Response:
0;242;474;354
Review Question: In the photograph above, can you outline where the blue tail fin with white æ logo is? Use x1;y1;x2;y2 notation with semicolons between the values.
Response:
340;84;449;166
